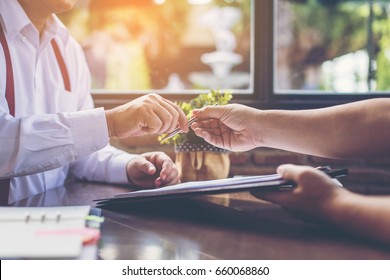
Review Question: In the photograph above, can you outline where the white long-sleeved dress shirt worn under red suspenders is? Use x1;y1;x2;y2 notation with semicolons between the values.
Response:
0;0;135;203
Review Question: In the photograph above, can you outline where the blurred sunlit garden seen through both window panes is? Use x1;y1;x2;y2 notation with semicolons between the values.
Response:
61;0;390;94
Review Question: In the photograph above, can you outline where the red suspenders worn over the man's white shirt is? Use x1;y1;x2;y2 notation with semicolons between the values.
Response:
0;24;71;206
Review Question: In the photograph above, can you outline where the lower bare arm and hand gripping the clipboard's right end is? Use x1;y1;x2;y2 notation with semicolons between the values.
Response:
252;165;390;244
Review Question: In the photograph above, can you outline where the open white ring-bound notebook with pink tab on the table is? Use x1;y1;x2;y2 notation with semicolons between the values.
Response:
0;206;97;259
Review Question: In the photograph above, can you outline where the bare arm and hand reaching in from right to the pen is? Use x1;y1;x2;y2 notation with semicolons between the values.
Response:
192;98;390;158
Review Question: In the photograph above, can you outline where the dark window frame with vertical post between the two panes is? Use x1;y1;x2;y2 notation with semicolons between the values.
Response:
92;0;390;109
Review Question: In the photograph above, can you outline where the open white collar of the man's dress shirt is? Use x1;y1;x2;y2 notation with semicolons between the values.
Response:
0;0;70;44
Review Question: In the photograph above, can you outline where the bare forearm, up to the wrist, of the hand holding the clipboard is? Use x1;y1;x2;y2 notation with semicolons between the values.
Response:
326;193;390;244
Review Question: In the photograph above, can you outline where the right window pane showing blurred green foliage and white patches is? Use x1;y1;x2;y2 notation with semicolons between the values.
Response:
274;0;390;94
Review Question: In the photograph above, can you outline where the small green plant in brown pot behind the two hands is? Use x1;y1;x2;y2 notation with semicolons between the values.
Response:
159;90;232;182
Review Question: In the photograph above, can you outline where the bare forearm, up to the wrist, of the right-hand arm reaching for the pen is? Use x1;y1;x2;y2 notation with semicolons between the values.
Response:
257;99;390;158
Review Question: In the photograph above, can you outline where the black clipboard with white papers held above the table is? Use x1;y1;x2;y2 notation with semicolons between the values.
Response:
95;166;348;207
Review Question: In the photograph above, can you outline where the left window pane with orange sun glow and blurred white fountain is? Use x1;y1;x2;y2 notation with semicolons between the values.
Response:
60;0;253;93
